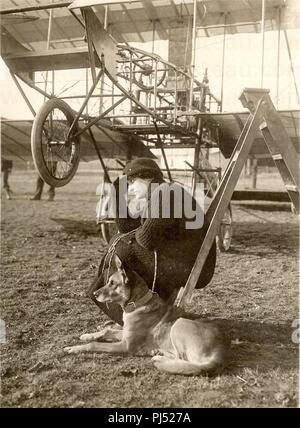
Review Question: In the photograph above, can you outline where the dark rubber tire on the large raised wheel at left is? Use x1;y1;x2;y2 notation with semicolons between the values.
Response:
31;98;80;187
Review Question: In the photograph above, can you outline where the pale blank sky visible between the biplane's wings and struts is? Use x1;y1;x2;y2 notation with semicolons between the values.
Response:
0;30;300;119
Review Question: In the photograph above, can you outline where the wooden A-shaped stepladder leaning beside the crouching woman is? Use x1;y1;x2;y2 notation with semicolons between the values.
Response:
174;88;300;306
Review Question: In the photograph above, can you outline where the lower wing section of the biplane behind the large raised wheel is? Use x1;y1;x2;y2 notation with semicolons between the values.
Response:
1;120;155;162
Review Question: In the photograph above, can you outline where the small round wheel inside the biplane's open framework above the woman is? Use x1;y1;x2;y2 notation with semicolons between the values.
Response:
133;55;166;91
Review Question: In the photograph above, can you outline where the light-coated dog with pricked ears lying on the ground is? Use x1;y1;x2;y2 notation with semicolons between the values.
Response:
64;255;229;375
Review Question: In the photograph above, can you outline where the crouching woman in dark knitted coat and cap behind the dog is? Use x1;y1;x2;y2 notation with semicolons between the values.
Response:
88;158;216;324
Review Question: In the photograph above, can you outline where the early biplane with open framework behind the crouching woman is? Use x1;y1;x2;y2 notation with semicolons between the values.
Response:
0;0;300;258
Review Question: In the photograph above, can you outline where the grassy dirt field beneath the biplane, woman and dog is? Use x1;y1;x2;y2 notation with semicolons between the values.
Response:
0;172;299;408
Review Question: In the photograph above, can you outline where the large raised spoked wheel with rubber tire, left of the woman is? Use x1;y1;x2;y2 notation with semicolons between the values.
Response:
31;98;80;187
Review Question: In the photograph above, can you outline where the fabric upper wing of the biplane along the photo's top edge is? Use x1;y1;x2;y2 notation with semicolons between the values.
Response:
0;0;300;51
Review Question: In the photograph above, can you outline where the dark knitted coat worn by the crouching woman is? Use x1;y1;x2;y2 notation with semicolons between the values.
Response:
90;182;216;300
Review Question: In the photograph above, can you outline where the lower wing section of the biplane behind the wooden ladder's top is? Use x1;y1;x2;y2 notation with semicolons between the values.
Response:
208;110;300;158
